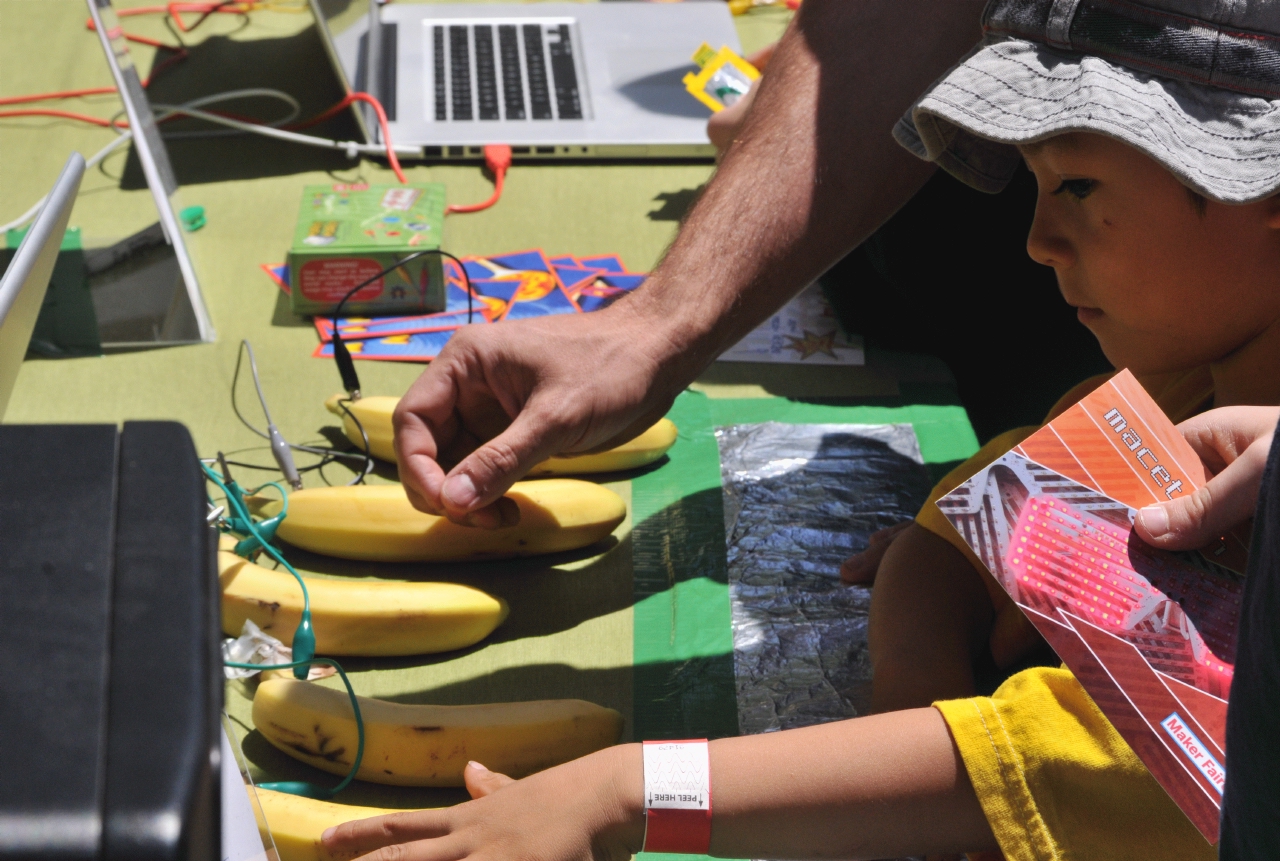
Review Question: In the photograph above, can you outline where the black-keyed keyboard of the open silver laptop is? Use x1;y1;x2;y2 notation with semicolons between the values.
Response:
429;19;584;122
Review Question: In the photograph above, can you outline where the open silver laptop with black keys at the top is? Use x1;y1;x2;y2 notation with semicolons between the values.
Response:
310;0;740;159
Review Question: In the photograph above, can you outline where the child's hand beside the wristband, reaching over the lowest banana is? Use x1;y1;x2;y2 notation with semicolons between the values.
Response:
323;745;644;861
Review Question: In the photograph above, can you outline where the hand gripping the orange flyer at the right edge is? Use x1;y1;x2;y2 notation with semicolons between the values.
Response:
1134;407;1280;550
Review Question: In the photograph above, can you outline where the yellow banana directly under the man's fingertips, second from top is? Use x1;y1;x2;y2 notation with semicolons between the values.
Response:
273;478;627;562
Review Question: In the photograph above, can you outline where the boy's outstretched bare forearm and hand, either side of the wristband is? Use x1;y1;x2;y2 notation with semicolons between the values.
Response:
324;709;997;861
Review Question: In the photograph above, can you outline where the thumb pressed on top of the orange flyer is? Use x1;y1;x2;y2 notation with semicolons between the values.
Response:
1134;434;1271;550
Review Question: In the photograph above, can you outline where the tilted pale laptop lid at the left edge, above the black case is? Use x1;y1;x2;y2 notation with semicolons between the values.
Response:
0;152;84;417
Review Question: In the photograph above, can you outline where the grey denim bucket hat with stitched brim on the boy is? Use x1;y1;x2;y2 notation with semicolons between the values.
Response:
893;0;1280;203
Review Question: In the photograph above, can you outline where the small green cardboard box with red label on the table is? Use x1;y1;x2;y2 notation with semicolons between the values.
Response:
289;183;445;316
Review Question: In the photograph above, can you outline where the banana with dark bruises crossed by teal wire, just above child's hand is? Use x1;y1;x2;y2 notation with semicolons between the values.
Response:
253;678;622;787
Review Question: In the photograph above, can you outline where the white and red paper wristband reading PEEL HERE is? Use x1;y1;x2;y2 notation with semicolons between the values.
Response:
643;738;712;855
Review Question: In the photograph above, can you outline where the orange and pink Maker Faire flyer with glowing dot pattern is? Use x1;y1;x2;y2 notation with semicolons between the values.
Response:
938;371;1245;843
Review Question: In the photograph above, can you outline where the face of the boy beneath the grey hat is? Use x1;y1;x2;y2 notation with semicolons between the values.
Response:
1020;133;1280;374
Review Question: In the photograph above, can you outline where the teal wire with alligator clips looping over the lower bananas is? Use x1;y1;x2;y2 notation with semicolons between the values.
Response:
200;457;365;798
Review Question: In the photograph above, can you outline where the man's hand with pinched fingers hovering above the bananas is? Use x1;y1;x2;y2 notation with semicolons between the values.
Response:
393;302;684;528
